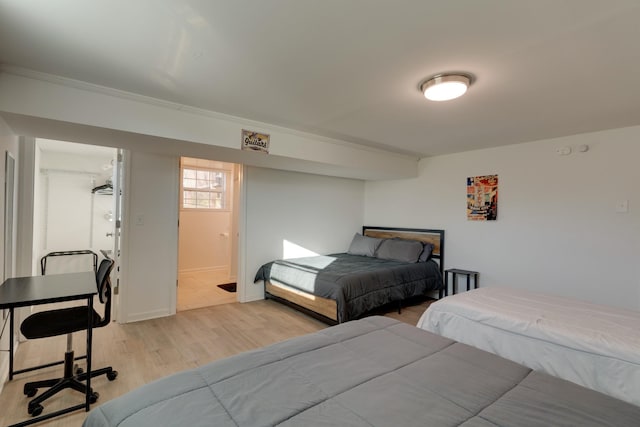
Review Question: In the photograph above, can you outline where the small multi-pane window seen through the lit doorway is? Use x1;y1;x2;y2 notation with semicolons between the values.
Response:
182;167;229;209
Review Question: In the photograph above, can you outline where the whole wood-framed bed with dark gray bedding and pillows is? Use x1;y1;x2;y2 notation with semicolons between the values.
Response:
255;226;444;324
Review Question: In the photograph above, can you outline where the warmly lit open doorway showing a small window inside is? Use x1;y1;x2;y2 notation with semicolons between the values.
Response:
176;157;240;311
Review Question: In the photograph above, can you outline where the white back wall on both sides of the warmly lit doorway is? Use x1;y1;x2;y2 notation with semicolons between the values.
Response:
112;160;364;322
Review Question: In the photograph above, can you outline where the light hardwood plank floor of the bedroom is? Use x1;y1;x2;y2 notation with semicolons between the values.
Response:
0;300;433;427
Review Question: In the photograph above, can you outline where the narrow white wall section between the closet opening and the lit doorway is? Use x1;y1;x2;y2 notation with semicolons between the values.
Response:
119;152;179;322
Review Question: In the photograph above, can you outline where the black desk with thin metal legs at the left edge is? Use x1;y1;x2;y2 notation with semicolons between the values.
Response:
0;271;98;426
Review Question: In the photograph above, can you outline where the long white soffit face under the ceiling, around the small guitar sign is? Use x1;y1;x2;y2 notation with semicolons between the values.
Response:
0;70;417;179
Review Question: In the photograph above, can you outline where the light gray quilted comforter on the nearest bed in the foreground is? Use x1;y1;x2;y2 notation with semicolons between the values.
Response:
83;317;640;427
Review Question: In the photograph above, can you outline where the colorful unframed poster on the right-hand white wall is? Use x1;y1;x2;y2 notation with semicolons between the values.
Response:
467;175;498;221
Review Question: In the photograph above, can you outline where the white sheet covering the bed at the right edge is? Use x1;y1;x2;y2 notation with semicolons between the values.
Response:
417;287;640;406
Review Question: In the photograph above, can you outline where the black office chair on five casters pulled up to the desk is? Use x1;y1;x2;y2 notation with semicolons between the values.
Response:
20;259;118;417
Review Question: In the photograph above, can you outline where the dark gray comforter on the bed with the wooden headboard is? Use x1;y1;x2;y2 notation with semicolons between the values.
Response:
254;253;444;322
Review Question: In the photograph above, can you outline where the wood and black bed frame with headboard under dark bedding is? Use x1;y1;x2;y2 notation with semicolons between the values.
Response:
264;225;444;325
